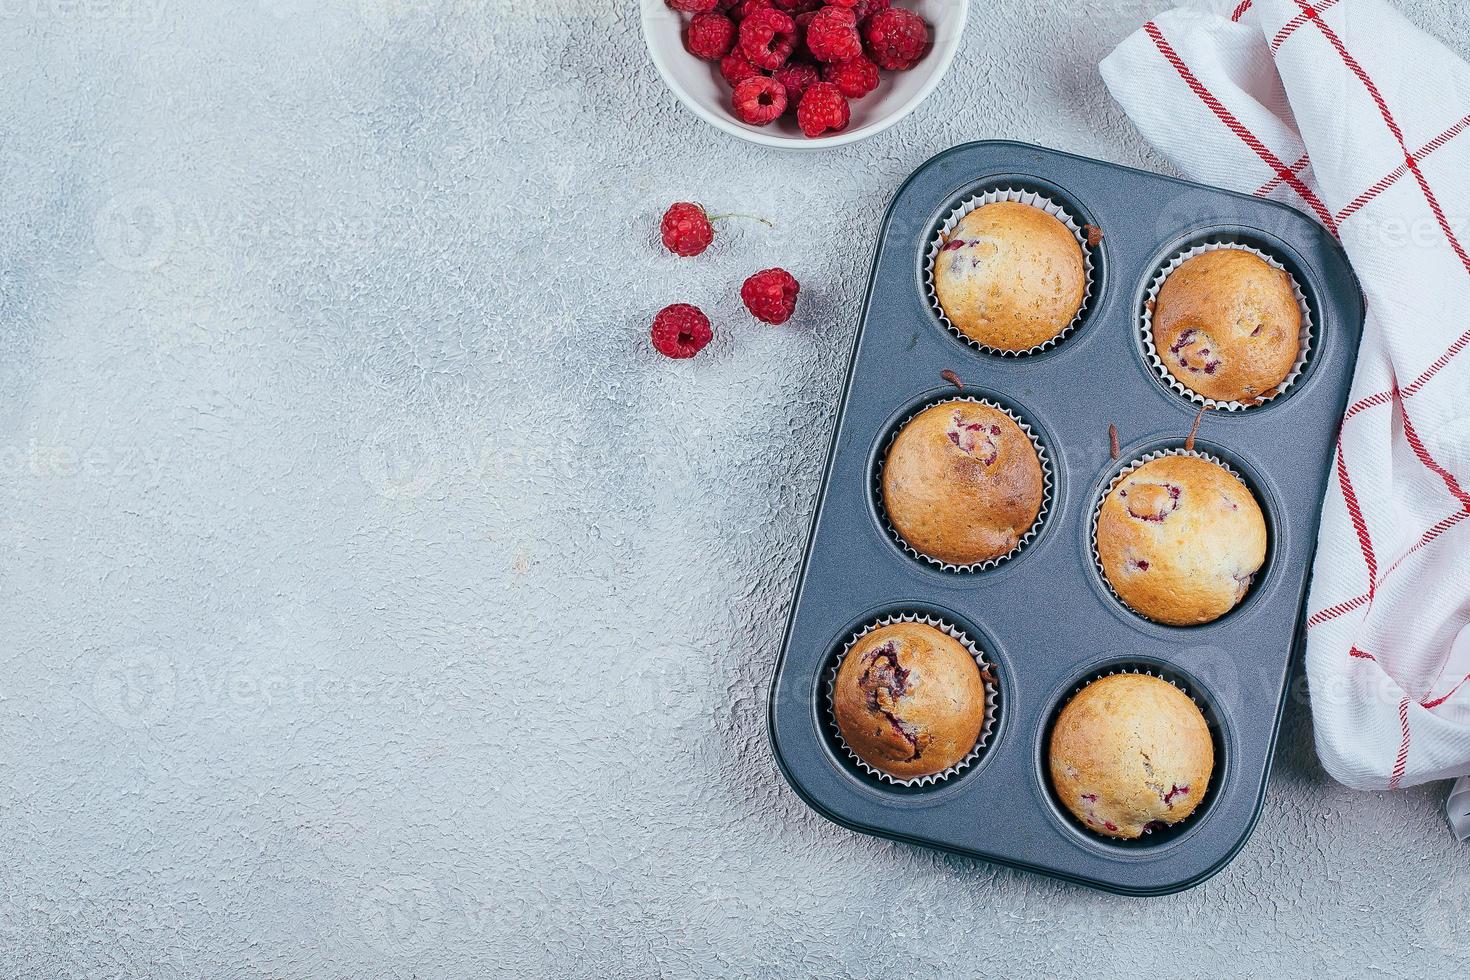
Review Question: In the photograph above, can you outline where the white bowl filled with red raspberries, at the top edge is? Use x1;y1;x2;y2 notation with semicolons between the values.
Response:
642;0;970;148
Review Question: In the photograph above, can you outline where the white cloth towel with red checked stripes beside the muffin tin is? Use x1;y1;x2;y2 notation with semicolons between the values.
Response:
1101;0;1470;836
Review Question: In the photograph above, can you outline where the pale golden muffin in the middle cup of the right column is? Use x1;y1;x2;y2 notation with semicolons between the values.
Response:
1097;455;1266;626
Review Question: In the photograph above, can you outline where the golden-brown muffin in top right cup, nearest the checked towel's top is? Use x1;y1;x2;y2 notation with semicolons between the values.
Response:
1152;248;1301;403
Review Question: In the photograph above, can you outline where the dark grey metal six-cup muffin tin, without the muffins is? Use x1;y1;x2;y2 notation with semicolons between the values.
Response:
769;141;1363;895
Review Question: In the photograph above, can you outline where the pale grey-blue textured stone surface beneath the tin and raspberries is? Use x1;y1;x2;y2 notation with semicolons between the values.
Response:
0;0;1470;979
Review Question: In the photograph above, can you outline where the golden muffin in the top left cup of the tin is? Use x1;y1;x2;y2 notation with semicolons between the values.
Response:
933;201;1088;351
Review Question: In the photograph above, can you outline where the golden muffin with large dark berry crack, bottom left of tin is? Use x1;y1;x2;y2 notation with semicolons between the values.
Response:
832;623;985;779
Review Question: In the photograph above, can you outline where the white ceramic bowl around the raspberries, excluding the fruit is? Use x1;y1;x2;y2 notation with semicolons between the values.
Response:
641;0;970;150
